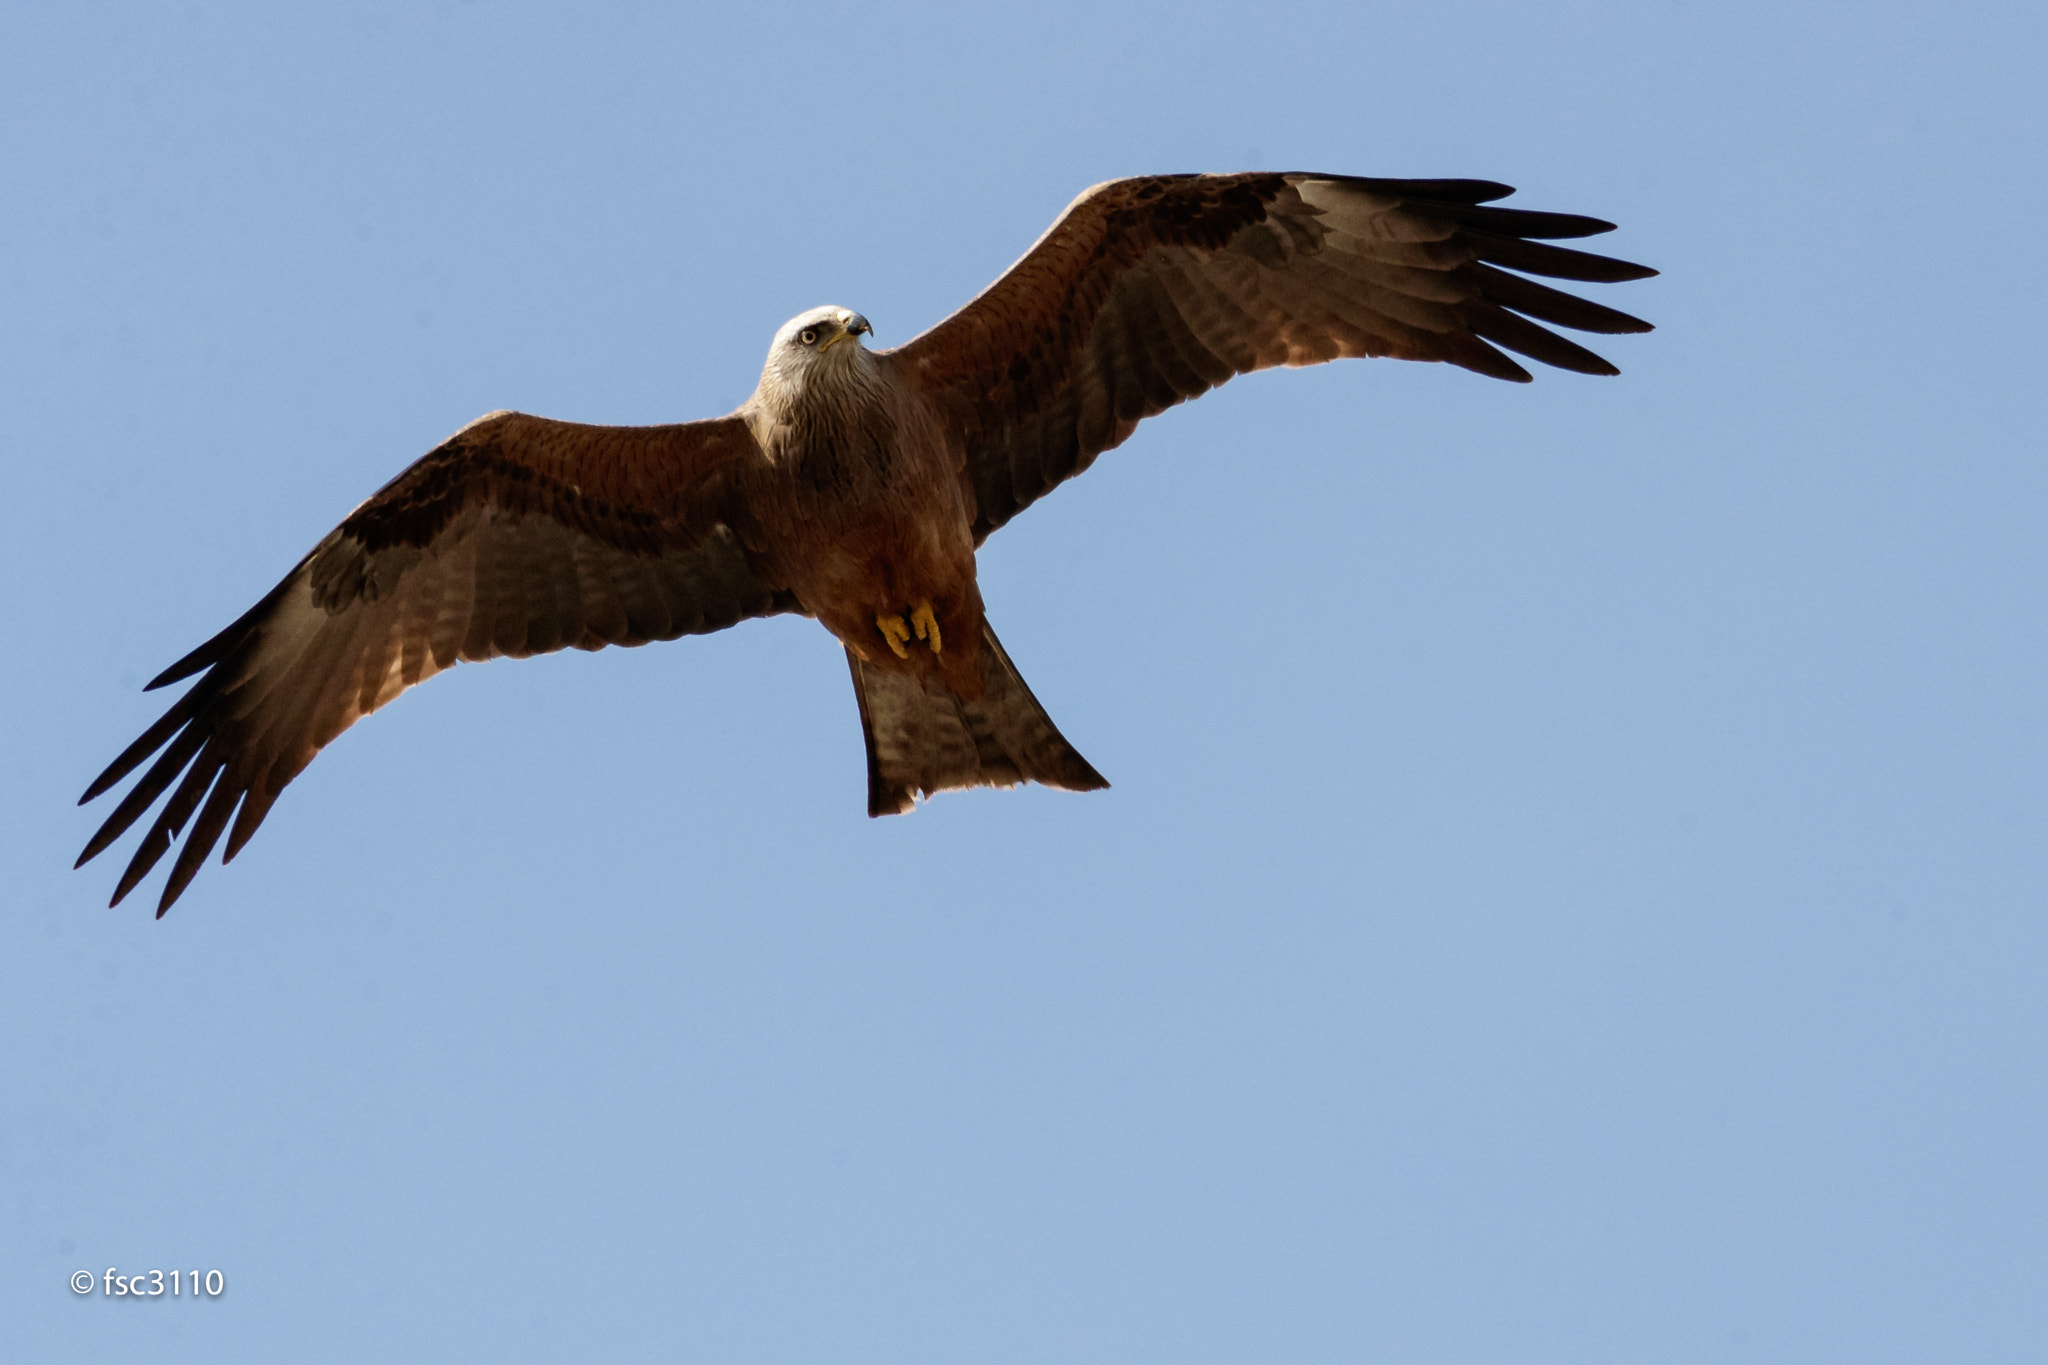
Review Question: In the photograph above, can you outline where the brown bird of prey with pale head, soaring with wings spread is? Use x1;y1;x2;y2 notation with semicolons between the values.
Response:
78;174;1655;915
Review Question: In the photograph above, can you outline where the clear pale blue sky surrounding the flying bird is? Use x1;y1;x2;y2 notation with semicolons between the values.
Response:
0;2;2048;1365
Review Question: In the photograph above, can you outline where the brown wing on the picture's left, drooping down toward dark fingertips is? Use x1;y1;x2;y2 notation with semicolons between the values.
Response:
78;413;799;915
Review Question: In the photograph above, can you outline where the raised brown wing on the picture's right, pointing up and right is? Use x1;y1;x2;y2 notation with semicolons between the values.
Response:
885;174;1657;544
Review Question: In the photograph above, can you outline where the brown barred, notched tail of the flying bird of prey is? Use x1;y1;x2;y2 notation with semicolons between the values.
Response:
846;624;1108;814
